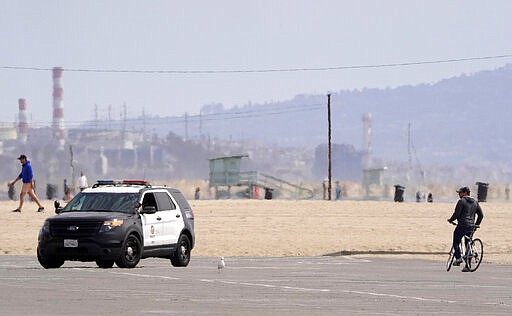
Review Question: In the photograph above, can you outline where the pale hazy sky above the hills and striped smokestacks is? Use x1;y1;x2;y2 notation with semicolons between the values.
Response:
0;0;512;125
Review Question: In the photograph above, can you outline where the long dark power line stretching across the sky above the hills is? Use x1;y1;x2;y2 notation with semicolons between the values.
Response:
0;54;512;74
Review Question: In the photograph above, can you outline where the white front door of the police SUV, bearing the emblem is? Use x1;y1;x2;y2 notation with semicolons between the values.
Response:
141;192;165;249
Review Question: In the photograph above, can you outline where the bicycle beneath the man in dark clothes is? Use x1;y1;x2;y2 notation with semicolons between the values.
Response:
446;222;484;272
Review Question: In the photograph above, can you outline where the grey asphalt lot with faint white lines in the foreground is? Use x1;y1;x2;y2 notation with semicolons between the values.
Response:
0;256;512;315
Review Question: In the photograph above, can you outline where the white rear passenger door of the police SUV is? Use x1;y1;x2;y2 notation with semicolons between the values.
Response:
155;189;184;245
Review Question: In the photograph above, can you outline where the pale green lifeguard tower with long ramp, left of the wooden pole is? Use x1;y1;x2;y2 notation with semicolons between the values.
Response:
209;155;313;199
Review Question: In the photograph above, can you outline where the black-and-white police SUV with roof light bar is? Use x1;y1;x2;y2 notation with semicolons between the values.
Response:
37;180;195;269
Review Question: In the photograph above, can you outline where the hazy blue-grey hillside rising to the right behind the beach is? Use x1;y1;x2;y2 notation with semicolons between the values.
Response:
171;65;504;169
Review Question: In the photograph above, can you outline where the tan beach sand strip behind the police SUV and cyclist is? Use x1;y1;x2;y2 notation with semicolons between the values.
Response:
0;200;512;264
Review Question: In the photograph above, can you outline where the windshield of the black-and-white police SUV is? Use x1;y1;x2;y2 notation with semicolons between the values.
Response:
62;192;139;213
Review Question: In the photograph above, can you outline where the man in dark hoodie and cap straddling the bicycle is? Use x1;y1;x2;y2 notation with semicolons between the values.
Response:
448;187;484;266
